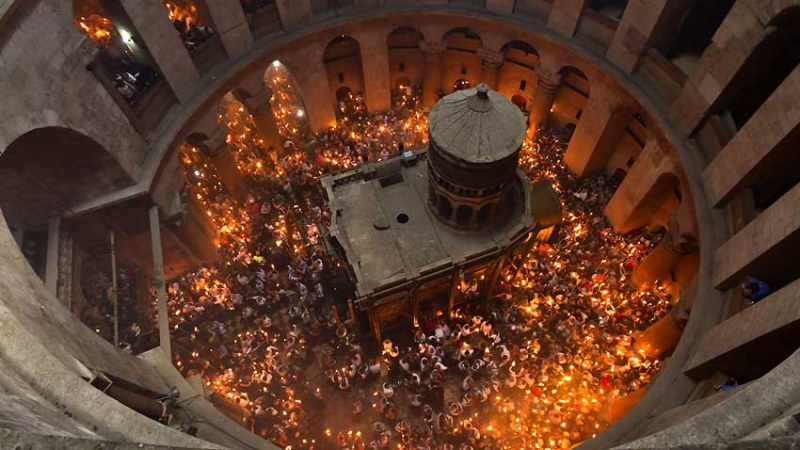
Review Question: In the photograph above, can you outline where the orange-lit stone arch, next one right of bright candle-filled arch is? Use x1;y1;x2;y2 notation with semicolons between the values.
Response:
322;34;364;118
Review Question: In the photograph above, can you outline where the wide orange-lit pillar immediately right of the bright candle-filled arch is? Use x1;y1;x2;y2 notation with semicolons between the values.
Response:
287;55;336;132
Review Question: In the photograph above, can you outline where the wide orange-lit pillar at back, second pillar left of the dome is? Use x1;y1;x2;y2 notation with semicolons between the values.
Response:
353;32;392;113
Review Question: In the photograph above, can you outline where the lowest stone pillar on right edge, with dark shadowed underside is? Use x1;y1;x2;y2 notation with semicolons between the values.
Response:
684;279;800;379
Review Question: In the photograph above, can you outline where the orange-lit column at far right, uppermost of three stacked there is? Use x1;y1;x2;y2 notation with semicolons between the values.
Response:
631;215;697;289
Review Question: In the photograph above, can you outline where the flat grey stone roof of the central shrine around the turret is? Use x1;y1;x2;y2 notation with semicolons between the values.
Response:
322;149;552;297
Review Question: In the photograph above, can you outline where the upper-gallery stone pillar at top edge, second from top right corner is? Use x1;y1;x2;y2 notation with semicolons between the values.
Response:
606;0;692;74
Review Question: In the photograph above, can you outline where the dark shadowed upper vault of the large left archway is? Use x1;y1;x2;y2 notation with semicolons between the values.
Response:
0;127;134;228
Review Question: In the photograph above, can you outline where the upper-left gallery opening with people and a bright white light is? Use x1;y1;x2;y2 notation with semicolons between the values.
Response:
72;0;177;132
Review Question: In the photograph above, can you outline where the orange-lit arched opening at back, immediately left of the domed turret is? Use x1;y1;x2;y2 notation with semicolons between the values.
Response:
386;26;425;109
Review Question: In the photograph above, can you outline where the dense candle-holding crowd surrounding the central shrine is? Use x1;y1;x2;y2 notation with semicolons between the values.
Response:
152;85;672;450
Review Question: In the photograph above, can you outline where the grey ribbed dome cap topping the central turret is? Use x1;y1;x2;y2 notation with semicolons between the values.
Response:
428;84;527;163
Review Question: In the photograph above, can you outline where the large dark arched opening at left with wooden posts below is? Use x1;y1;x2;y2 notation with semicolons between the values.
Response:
0;127;159;352
